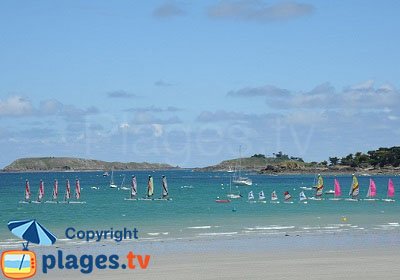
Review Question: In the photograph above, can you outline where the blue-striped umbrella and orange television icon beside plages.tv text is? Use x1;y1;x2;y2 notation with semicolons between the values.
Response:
1;220;57;279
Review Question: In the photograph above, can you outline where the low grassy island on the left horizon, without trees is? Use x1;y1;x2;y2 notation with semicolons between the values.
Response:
3;157;179;172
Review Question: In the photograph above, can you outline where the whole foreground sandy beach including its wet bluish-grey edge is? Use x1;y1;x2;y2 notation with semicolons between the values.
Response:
31;236;400;279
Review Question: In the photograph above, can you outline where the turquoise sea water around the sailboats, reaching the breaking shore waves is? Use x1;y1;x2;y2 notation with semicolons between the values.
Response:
0;170;400;244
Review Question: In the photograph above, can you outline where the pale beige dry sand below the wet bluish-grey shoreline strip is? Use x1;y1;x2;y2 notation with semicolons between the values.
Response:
37;242;400;280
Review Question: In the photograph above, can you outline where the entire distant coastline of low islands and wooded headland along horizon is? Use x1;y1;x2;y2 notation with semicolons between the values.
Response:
2;146;400;176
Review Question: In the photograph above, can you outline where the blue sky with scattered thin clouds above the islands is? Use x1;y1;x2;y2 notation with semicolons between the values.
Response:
0;0;400;167
